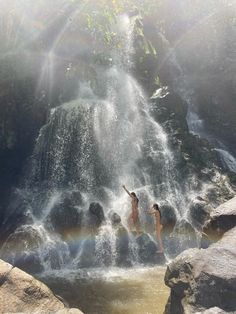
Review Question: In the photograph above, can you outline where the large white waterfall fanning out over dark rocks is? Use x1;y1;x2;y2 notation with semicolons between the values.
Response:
3;15;208;270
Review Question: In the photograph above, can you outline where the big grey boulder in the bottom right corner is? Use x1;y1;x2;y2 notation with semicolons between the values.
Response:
165;227;236;314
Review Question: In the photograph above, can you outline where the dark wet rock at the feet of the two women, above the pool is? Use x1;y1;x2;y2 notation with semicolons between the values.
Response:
136;233;165;264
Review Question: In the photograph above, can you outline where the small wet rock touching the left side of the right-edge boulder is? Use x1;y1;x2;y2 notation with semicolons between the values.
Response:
189;196;213;230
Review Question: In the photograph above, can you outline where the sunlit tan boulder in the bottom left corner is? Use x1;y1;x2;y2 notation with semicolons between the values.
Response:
0;260;82;314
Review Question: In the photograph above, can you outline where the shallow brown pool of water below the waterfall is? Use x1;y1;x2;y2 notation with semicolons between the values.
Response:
40;267;169;314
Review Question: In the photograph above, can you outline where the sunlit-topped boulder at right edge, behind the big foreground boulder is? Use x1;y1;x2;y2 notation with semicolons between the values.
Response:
203;197;236;241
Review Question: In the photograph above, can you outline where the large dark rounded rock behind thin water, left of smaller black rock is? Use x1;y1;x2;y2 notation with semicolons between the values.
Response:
50;197;83;238
